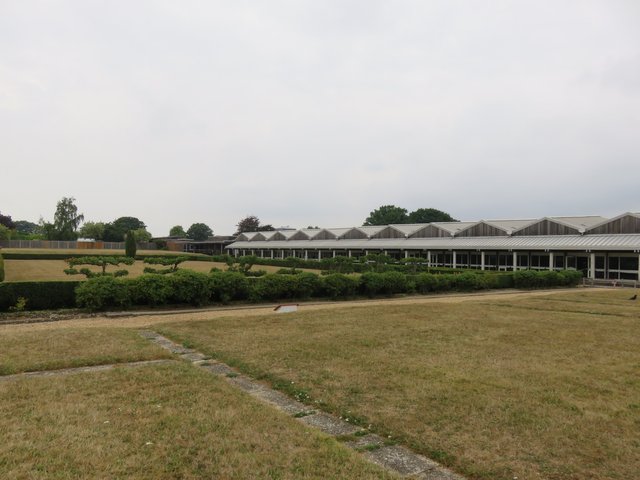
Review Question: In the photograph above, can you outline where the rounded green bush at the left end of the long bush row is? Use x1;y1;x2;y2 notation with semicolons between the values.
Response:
76;276;132;311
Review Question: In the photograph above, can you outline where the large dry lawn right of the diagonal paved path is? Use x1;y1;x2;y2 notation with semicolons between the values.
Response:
161;290;640;480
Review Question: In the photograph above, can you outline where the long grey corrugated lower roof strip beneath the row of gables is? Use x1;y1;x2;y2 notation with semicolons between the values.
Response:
227;234;640;252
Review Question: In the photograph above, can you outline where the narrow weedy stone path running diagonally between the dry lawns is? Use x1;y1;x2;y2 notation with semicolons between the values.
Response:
140;330;464;480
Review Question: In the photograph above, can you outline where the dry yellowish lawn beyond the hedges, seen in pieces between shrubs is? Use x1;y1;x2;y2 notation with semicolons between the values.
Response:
4;260;319;282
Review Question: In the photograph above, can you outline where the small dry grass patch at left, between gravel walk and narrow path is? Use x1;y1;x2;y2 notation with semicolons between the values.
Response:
0;328;171;375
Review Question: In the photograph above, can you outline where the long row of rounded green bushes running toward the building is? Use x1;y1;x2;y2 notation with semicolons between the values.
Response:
72;270;581;310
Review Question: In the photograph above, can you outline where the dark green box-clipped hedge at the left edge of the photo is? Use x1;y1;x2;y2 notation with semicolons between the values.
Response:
0;281;80;312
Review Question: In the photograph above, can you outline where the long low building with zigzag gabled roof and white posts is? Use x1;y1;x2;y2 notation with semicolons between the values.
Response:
226;213;640;280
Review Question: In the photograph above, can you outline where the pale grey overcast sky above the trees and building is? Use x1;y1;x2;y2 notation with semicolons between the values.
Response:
0;0;640;236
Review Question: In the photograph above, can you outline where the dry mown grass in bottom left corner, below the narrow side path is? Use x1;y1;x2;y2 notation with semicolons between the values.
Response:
0;363;397;480
